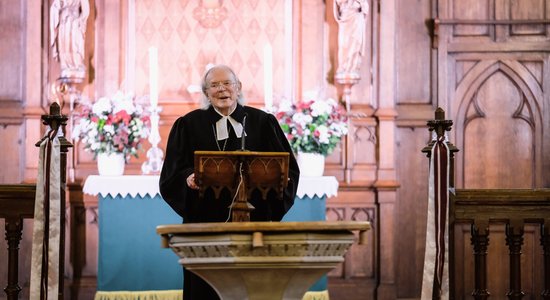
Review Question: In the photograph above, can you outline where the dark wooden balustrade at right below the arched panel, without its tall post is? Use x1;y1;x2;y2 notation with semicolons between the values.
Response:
449;189;550;299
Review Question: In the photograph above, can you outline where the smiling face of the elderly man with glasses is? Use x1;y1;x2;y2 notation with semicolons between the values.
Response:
206;68;241;115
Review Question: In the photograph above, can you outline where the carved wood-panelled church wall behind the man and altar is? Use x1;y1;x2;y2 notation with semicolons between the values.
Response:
0;0;550;299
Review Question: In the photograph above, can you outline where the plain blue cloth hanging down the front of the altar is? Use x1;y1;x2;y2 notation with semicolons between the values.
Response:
97;195;327;291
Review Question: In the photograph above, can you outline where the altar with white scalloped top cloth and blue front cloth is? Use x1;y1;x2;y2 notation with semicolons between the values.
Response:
83;175;338;298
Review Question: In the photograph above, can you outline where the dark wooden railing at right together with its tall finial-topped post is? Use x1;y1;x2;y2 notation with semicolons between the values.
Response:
422;108;550;300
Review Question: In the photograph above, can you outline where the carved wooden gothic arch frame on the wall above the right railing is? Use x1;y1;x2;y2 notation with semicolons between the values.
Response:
449;60;544;187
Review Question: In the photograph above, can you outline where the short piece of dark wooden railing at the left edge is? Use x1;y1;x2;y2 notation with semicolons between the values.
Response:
0;184;36;299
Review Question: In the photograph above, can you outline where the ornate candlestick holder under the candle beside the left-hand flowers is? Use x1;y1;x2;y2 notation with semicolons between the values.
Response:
141;106;164;174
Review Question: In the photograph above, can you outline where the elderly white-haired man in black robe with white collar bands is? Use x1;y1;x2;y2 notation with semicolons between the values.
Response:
160;65;300;300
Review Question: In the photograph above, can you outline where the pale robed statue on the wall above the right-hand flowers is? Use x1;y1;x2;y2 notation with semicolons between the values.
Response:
334;0;369;80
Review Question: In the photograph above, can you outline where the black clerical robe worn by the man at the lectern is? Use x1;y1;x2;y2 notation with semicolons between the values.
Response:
160;105;300;299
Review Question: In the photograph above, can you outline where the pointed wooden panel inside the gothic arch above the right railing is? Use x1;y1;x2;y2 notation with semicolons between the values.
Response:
460;72;535;188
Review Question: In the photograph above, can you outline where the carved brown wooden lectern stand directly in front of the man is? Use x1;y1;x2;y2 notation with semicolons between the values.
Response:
195;151;289;222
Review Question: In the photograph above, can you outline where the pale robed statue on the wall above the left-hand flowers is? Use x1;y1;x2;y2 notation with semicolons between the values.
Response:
50;0;90;80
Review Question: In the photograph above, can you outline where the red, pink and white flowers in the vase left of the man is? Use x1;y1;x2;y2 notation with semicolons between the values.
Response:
73;92;150;161
